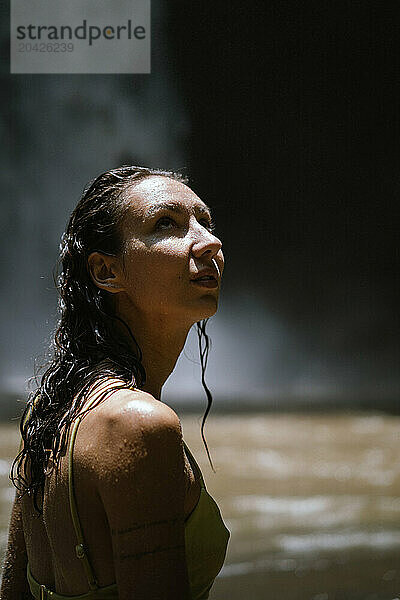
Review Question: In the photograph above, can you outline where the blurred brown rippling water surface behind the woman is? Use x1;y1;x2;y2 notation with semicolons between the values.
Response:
0;413;400;600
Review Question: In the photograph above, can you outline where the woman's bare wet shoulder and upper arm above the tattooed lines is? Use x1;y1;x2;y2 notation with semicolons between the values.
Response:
96;390;186;527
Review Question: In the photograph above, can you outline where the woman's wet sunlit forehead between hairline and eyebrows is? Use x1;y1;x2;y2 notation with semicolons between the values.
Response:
125;175;210;220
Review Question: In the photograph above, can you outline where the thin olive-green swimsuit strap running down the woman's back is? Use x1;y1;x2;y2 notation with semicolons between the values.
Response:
68;397;99;590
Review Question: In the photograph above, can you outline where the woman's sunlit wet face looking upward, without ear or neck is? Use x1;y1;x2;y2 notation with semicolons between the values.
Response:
115;176;224;323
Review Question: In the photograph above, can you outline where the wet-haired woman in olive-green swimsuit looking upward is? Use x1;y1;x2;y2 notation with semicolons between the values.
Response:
1;167;230;600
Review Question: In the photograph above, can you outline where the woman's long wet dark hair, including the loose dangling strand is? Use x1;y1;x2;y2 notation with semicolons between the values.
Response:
10;166;214;512
